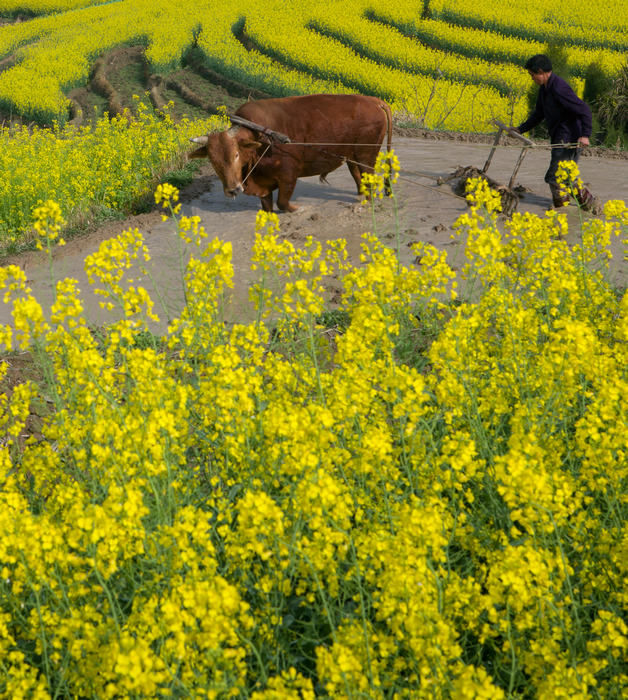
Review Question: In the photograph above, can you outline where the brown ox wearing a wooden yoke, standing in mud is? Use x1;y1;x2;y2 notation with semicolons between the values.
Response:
190;95;392;211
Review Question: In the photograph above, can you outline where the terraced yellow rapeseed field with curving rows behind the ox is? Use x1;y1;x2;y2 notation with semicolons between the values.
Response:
0;0;628;126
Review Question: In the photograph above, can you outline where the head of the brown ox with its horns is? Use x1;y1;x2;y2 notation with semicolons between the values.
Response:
189;127;262;197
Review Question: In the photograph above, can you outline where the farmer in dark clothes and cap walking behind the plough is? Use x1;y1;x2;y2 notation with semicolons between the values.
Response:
516;54;596;211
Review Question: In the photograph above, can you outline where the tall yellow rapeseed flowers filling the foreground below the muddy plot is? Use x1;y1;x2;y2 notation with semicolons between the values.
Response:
0;169;628;700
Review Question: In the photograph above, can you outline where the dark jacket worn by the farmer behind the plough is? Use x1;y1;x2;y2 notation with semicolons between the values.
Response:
517;73;592;143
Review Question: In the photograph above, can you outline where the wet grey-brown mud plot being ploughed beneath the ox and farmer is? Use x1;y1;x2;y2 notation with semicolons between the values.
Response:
0;137;628;332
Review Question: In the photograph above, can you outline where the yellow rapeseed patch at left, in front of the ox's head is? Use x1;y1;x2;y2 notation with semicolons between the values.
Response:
0;105;226;249
